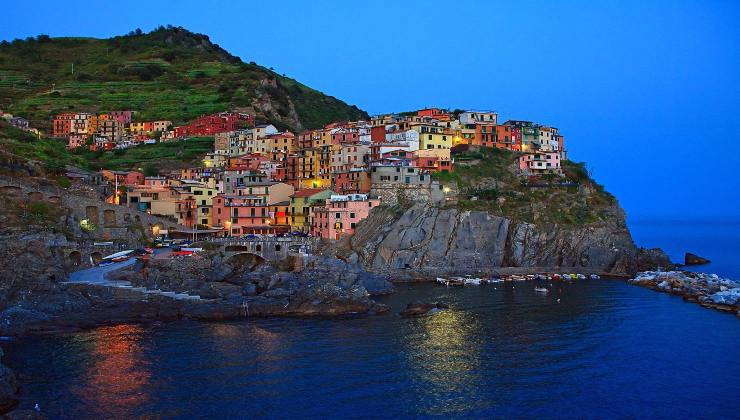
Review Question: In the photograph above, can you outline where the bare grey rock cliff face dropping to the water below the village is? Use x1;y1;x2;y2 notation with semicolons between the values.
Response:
351;204;670;275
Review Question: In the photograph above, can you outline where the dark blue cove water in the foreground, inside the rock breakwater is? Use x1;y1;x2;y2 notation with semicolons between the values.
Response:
3;280;740;418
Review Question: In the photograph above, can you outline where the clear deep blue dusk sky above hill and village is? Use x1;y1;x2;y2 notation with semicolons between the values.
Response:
0;0;740;220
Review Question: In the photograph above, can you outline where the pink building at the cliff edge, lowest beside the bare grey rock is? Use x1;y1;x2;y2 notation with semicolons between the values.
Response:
311;194;380;240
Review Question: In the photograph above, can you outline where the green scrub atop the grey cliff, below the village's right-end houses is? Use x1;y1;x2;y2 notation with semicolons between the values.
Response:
434;148;618;225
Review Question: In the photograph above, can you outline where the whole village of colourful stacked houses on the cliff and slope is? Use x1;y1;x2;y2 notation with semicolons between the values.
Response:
2;108;566;240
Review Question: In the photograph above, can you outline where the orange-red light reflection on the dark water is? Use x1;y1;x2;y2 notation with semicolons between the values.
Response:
74;325;152;416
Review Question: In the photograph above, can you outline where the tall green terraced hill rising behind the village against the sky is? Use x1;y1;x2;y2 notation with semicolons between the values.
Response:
0;27;367;131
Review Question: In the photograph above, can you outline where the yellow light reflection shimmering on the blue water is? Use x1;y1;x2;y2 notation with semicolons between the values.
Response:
404;310;483;415
